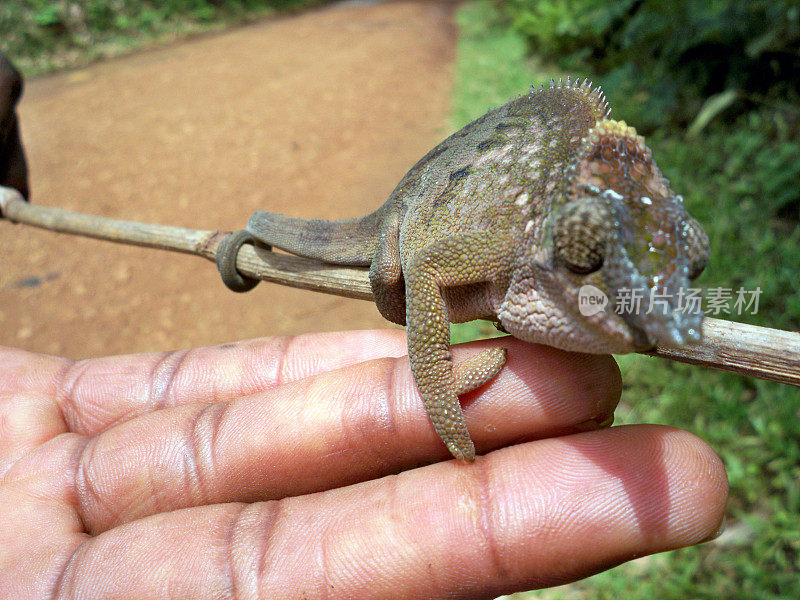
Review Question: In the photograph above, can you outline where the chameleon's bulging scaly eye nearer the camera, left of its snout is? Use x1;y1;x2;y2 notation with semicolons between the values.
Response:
553;199;609;275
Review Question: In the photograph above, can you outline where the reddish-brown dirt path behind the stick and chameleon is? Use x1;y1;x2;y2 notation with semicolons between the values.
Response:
0;2;454;358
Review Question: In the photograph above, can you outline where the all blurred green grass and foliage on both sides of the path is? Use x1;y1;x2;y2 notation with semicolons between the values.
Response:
0;0;800;600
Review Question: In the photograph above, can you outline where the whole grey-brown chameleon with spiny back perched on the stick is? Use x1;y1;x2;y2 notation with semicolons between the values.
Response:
218;78;709;462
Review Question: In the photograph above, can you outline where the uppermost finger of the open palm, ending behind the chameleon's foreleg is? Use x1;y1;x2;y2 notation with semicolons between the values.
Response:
0;329;406;441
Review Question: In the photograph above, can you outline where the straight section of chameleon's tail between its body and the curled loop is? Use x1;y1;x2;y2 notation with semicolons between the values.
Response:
247;207;386;266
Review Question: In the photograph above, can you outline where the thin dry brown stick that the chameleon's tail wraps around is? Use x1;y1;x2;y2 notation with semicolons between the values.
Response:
0;186;800;387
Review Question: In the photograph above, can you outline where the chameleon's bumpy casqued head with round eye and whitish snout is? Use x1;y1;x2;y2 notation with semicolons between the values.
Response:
537;120;708;352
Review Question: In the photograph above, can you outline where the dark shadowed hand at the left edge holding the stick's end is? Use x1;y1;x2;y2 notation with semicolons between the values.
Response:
0;54;30;199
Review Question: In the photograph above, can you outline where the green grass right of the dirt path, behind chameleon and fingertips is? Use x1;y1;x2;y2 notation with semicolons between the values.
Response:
452;1;800;600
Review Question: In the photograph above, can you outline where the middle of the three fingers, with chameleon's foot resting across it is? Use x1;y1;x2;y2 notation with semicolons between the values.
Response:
40;340;619;533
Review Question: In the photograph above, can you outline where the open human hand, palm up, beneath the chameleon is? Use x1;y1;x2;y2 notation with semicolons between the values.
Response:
0;331;727;600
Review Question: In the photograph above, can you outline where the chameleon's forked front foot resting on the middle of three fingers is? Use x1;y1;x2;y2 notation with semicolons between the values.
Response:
420;348;506;462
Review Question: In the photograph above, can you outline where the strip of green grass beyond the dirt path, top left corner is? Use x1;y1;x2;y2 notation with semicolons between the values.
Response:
0;0;327;76
